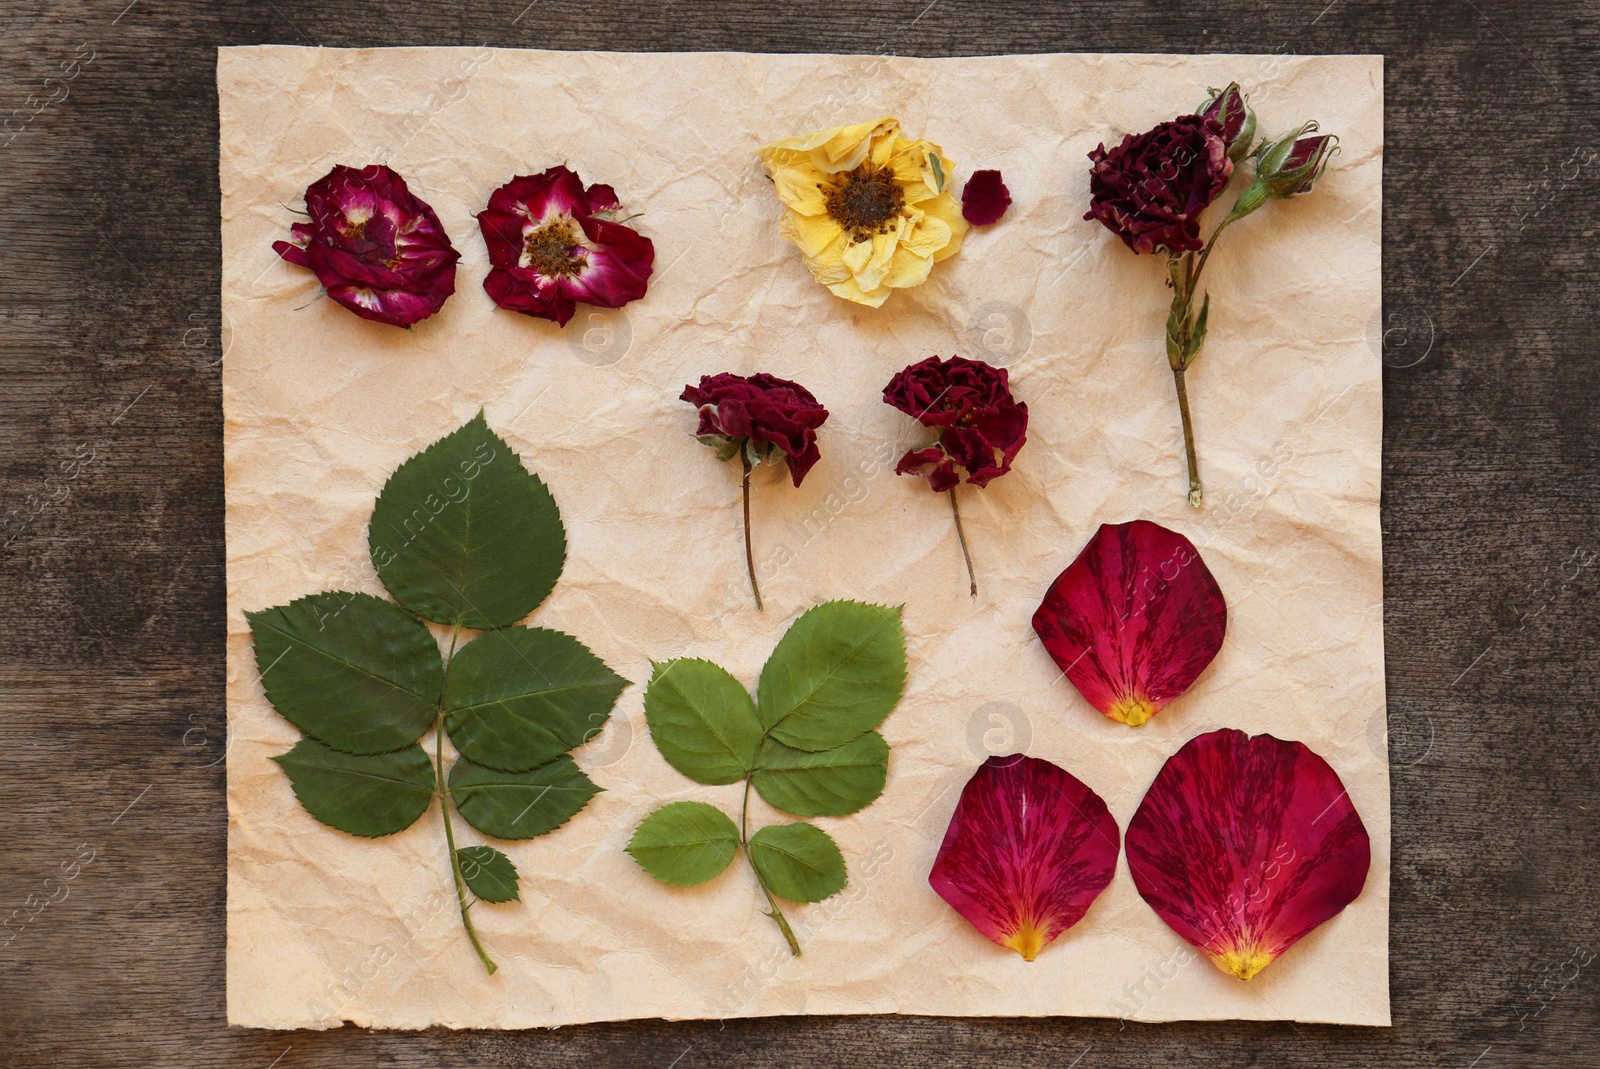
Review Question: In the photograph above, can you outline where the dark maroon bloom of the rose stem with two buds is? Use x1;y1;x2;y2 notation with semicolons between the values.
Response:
1083;115;1234;253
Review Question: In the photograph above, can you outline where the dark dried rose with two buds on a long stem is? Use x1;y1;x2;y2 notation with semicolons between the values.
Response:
1083;82;1338;507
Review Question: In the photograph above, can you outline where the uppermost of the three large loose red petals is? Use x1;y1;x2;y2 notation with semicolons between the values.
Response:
1034;520;1227;727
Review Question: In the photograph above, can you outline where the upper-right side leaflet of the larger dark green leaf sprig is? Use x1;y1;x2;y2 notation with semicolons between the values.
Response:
445;627;627;771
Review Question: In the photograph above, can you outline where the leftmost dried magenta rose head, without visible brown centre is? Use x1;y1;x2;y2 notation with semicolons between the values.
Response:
272;165;461;326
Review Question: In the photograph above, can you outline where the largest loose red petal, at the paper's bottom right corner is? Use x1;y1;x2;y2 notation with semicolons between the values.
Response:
1128;728;1371;979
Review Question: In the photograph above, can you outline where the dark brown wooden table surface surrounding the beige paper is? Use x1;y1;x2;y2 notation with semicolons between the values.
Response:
0;0;1600;1069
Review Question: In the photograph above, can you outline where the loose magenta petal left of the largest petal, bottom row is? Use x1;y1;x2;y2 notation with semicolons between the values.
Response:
928;754;1120;962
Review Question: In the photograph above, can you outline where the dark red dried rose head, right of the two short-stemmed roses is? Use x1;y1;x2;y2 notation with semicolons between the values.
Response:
883;357;1027;493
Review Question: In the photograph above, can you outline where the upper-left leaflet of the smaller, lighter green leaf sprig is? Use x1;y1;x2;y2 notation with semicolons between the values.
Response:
645;658;762;786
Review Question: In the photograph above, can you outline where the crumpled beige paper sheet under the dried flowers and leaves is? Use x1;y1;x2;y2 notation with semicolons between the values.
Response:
218;46;1389;1027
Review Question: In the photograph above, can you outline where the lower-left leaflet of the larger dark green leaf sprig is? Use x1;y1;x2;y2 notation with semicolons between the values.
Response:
272;739;434;839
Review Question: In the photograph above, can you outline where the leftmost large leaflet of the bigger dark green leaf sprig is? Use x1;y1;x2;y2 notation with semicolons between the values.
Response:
245;591;443;754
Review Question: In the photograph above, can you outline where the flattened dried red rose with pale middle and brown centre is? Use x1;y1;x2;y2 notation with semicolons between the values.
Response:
478;166;656;326
